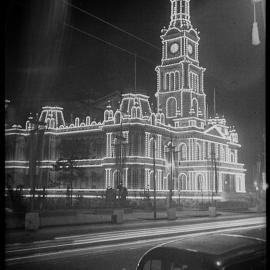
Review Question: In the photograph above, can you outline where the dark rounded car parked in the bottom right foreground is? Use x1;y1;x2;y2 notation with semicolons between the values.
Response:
137;233;266;270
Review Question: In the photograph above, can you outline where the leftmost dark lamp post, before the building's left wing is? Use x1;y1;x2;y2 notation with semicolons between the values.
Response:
28;114;46;211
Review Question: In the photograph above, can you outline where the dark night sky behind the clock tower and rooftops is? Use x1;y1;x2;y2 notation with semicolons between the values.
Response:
5;0;265;189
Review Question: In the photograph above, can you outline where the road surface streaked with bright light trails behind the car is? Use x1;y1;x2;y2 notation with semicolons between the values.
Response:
5;217;266;270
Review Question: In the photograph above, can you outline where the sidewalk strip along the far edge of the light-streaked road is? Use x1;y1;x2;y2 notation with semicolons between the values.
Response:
5;210;261;244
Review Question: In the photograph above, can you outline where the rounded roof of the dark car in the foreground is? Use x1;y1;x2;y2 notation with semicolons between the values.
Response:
159;233;265;255
